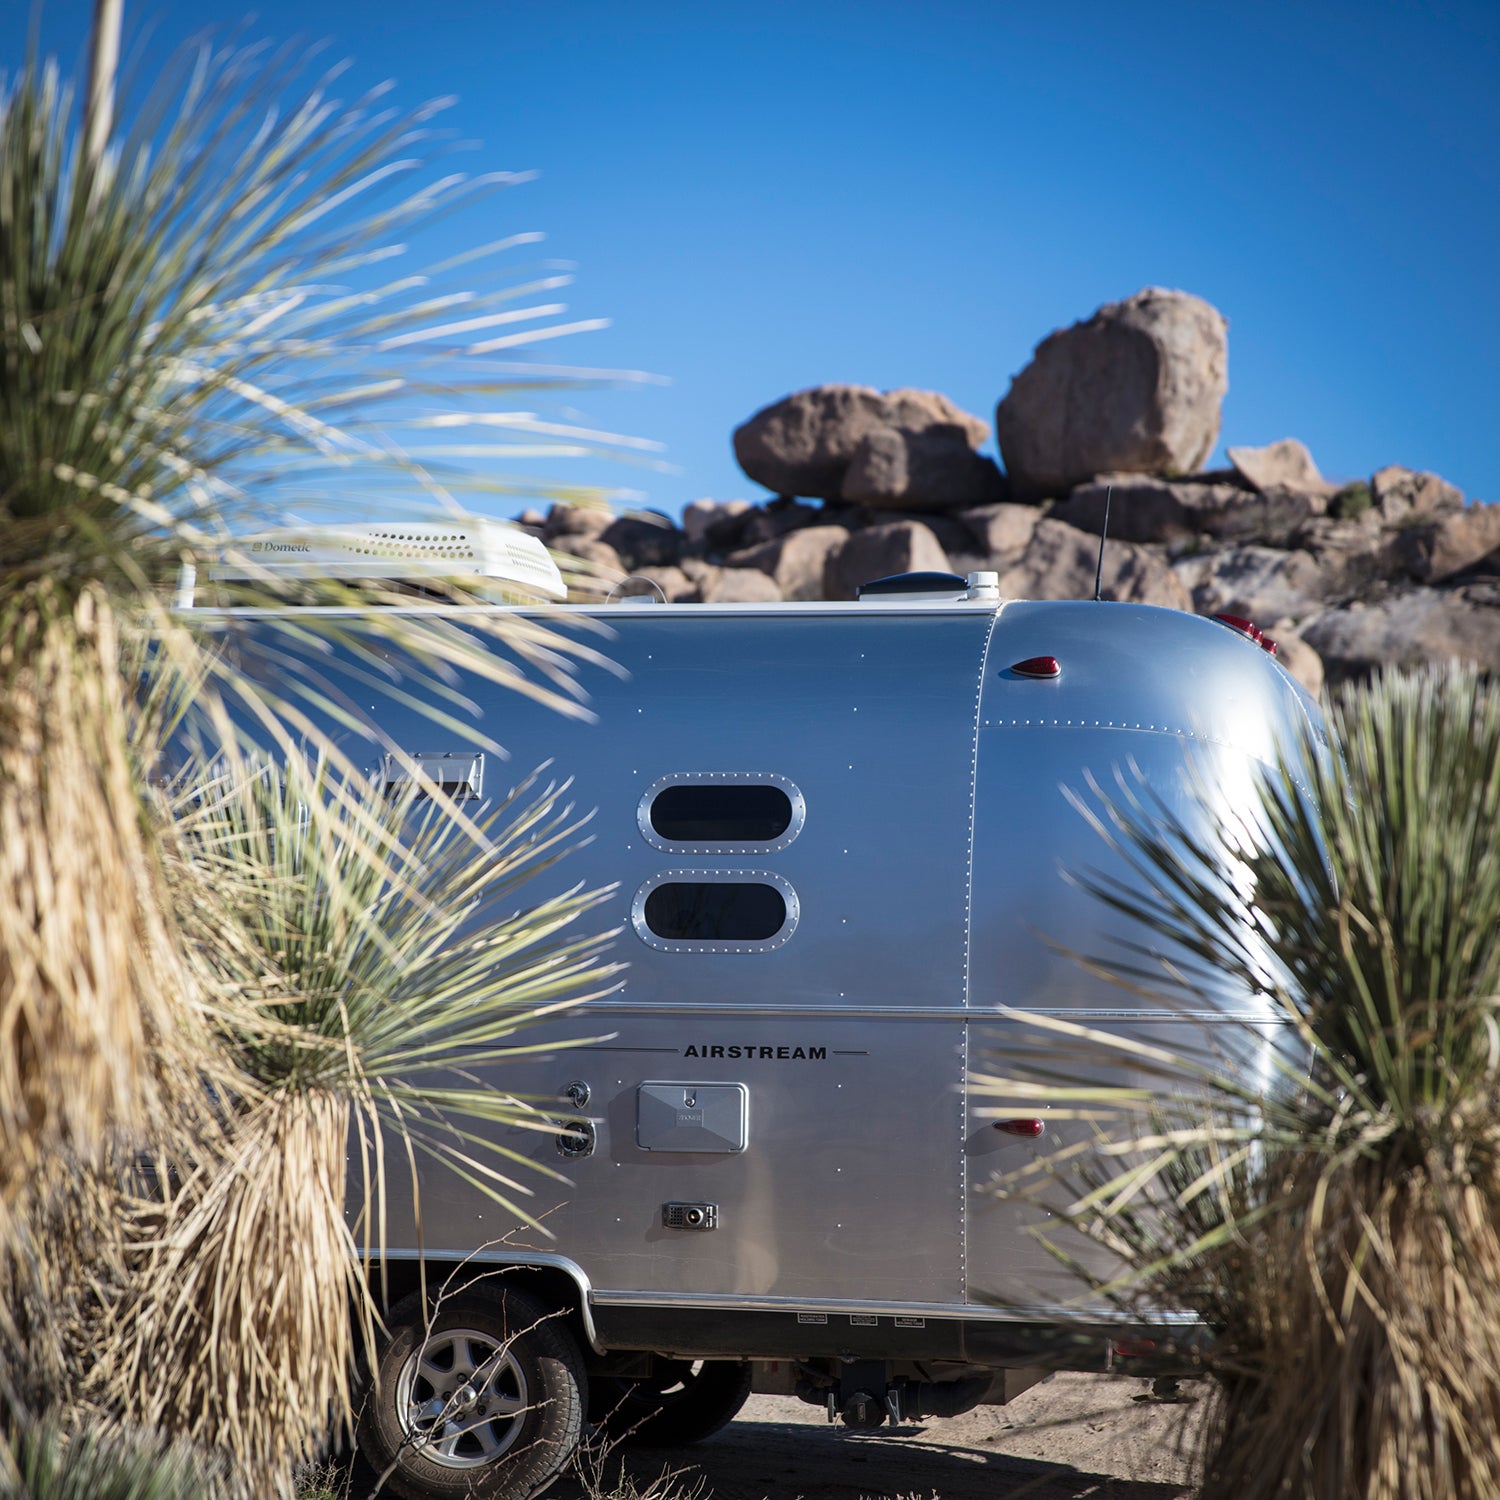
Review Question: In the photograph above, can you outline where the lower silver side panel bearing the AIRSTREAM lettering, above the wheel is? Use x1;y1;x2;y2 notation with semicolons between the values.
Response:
369;1004;963;1322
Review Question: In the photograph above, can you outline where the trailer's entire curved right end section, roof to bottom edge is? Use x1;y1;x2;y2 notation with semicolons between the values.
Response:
965;603;1314;1317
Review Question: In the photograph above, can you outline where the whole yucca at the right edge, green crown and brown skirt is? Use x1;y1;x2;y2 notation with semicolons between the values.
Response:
972;666;1500;1500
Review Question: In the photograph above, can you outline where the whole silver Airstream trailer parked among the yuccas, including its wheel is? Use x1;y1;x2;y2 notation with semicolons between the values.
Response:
185;525;1317;1500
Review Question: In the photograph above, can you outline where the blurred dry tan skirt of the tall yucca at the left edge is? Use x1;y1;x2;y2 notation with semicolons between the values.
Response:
0;581;192;1236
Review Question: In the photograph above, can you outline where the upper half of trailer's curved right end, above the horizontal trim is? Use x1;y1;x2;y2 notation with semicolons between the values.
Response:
969;603;1308;1011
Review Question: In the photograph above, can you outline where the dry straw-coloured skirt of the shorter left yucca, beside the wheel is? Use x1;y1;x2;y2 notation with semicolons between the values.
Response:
92;1091;360;1494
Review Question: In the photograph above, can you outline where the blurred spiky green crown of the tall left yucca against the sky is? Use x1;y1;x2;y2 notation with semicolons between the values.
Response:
0;47;641;579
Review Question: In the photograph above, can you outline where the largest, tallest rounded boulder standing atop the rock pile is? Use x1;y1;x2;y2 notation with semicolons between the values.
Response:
995;287;1229;500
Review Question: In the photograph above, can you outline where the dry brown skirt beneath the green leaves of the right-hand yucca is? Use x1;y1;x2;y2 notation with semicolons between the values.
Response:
1202;1140;1500;1500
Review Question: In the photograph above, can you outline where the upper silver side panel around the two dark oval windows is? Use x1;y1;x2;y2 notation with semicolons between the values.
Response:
237;606;995;1007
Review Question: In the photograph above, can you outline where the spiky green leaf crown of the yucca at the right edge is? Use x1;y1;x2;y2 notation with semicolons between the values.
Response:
1050;666;1500;1155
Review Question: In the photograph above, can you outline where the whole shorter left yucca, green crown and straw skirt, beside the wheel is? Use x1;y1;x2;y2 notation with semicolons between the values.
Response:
86;762;614;1493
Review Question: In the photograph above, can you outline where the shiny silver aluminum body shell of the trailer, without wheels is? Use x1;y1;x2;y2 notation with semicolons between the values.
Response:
245;600;1317;1358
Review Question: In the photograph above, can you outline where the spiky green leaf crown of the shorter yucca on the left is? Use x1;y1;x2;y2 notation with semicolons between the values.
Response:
174;761;617;1218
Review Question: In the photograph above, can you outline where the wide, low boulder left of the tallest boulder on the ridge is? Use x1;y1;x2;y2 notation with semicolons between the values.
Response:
735;386;1005;512
